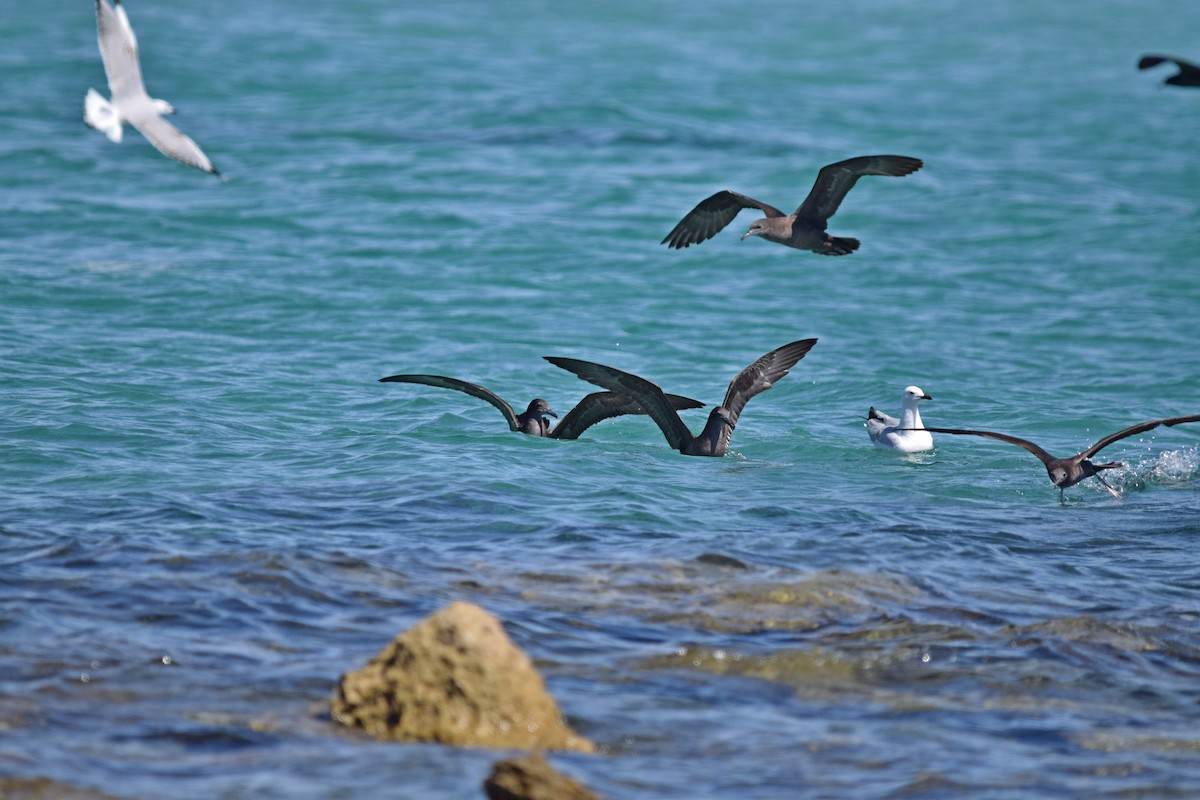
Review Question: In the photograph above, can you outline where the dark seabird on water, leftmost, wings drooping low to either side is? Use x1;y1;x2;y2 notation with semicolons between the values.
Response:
379;375;704;439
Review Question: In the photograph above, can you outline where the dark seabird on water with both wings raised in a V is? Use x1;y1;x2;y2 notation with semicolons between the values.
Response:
546;339;817;456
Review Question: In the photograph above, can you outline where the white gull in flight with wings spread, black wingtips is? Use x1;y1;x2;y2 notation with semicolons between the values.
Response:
83;0;221;176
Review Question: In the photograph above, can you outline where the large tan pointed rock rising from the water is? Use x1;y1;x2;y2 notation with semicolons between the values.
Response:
331;602;595;752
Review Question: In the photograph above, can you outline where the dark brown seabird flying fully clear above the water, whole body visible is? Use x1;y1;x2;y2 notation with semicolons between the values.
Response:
660;156;924;255
